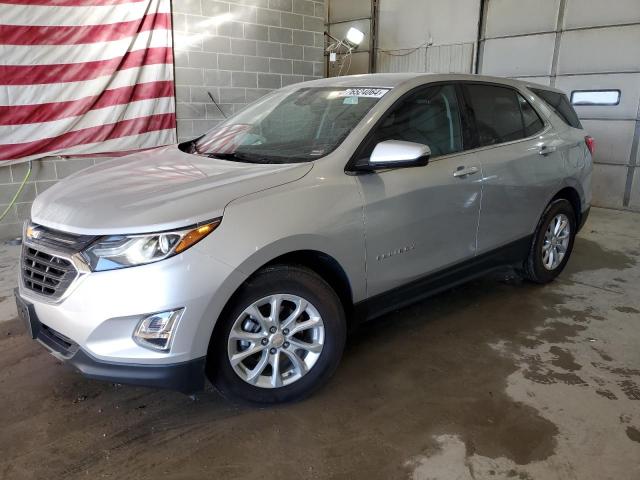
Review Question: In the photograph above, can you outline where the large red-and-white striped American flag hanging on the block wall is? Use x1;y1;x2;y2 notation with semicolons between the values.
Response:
0;0;176;164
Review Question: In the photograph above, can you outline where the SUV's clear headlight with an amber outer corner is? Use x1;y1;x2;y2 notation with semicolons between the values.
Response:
83;218;221;272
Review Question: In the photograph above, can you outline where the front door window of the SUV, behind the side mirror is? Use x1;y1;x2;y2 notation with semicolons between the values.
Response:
363;85;462;158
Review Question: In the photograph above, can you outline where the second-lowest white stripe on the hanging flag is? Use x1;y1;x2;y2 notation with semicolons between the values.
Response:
0;64;173;106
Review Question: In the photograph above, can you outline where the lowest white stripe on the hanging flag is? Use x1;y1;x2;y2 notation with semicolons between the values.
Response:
0;97;175;144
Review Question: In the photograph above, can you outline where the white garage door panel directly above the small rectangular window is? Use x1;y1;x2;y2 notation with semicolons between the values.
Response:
558;24;640;74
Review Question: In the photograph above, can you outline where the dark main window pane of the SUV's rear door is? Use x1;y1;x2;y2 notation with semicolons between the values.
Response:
465;84;528;147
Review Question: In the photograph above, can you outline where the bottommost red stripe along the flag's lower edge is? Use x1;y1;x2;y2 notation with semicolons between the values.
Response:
0;113;176;160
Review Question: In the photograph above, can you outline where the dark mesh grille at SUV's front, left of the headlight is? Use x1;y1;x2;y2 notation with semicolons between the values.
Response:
22;245;78;299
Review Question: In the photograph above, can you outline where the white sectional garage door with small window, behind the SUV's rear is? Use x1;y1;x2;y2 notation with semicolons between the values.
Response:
479;0;640;210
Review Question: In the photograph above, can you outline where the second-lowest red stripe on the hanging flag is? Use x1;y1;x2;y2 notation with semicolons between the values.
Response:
0;80;173;125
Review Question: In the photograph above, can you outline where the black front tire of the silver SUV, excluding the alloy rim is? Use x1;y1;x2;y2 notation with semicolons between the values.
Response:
207;266;346;404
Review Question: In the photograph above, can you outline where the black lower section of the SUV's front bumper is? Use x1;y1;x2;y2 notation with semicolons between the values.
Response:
15;289;205;394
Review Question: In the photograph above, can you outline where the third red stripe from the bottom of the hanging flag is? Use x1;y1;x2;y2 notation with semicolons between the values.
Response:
0;47;173;85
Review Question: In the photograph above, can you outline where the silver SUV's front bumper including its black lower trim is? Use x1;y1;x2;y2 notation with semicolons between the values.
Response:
17;233;246;391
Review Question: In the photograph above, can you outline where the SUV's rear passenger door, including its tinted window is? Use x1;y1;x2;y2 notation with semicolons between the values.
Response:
463;83;564;254
